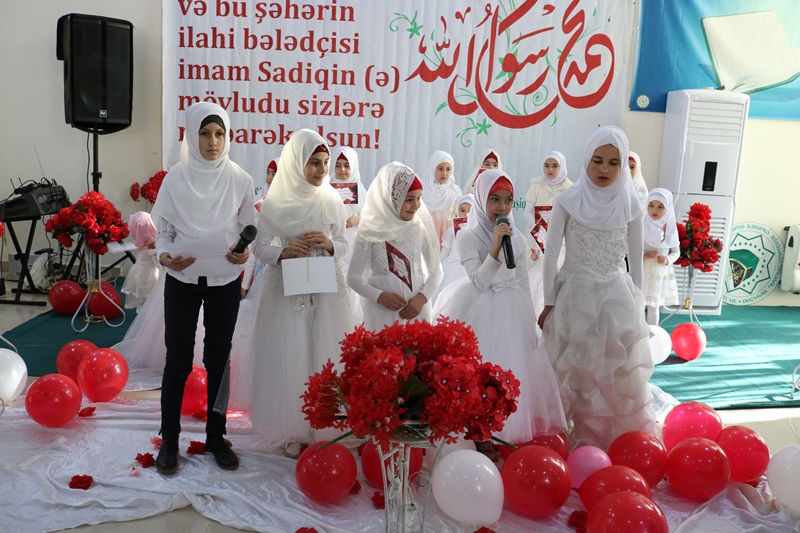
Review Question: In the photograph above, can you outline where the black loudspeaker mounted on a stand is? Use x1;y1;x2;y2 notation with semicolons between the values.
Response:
56;13;133;135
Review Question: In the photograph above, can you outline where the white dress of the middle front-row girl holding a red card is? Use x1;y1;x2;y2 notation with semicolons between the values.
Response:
347;224;442;331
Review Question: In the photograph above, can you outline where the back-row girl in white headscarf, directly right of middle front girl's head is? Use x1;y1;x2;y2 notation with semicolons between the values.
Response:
422;150;461;245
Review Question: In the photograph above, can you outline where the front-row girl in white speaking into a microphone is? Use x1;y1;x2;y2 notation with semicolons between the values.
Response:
434;170;566;459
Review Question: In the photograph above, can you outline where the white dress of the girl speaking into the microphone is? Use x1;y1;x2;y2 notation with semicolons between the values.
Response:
434;230;566;443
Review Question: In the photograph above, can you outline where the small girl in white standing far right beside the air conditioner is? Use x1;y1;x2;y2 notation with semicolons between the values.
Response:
642;188;681;326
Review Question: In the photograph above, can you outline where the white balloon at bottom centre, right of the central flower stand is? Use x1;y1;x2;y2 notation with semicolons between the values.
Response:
433;450;505;527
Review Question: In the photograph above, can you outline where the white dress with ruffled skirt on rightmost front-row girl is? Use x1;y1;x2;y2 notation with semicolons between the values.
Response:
542;212;655;450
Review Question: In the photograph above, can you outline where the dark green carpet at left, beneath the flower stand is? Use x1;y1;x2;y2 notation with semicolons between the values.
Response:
0;309;136;376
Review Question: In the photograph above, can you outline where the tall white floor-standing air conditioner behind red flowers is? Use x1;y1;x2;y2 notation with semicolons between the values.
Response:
658;89;750;315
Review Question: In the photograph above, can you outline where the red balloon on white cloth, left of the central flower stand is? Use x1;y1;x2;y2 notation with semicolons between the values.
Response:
294;442;358;503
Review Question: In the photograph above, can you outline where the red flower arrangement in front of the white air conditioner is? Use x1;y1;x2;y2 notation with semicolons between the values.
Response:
675;203;722;272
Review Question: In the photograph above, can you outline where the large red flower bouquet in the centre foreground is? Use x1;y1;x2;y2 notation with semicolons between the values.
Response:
301;318;519;444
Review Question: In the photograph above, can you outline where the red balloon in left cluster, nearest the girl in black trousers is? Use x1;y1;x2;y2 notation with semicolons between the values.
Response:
78;348;128;402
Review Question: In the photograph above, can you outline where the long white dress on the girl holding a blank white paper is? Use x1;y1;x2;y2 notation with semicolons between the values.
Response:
242;220;360;443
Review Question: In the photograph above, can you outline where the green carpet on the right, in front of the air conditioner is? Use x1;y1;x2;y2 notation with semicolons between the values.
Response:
651;305;800;409
